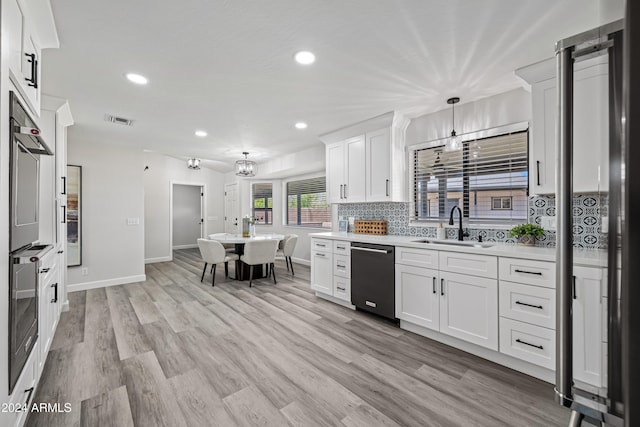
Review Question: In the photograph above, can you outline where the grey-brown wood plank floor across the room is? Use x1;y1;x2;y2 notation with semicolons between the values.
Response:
27;250;568;427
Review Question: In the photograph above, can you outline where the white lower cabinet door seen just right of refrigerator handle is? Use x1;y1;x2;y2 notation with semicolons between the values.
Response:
573;267;603;387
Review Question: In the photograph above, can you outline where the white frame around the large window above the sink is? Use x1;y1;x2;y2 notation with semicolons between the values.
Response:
405;122;531;228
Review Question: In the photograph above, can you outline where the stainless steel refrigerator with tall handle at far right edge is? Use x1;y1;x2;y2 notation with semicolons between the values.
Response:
555;0;640;426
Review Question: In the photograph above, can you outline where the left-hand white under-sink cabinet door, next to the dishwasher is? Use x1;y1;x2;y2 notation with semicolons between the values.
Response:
396;264;440;331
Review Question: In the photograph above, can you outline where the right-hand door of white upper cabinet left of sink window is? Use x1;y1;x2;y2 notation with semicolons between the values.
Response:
365;128;391;202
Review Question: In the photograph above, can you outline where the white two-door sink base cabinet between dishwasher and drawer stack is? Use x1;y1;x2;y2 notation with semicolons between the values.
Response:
396;248;498;350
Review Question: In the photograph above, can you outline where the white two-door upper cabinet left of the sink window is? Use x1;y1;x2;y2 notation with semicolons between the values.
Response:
320;112;409;203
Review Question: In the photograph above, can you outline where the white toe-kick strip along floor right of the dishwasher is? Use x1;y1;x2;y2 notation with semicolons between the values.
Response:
400;320;555;384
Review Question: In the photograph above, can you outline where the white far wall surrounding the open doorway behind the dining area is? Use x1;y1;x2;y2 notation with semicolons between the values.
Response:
141;152;225;263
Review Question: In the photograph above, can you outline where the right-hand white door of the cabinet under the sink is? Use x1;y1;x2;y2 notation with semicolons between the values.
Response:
438;271;498;350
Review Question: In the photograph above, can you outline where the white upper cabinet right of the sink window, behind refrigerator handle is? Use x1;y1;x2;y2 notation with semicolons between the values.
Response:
516;56;609;194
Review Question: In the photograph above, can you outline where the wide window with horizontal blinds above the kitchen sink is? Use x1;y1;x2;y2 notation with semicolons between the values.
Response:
412;131;529;223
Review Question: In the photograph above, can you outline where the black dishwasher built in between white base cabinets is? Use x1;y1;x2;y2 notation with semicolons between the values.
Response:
351;242;396;320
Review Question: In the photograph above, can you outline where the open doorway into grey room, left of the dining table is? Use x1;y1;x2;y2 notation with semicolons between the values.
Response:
171;184;204;249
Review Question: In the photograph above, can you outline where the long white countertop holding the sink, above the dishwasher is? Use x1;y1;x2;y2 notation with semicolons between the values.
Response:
309;232;607;267
